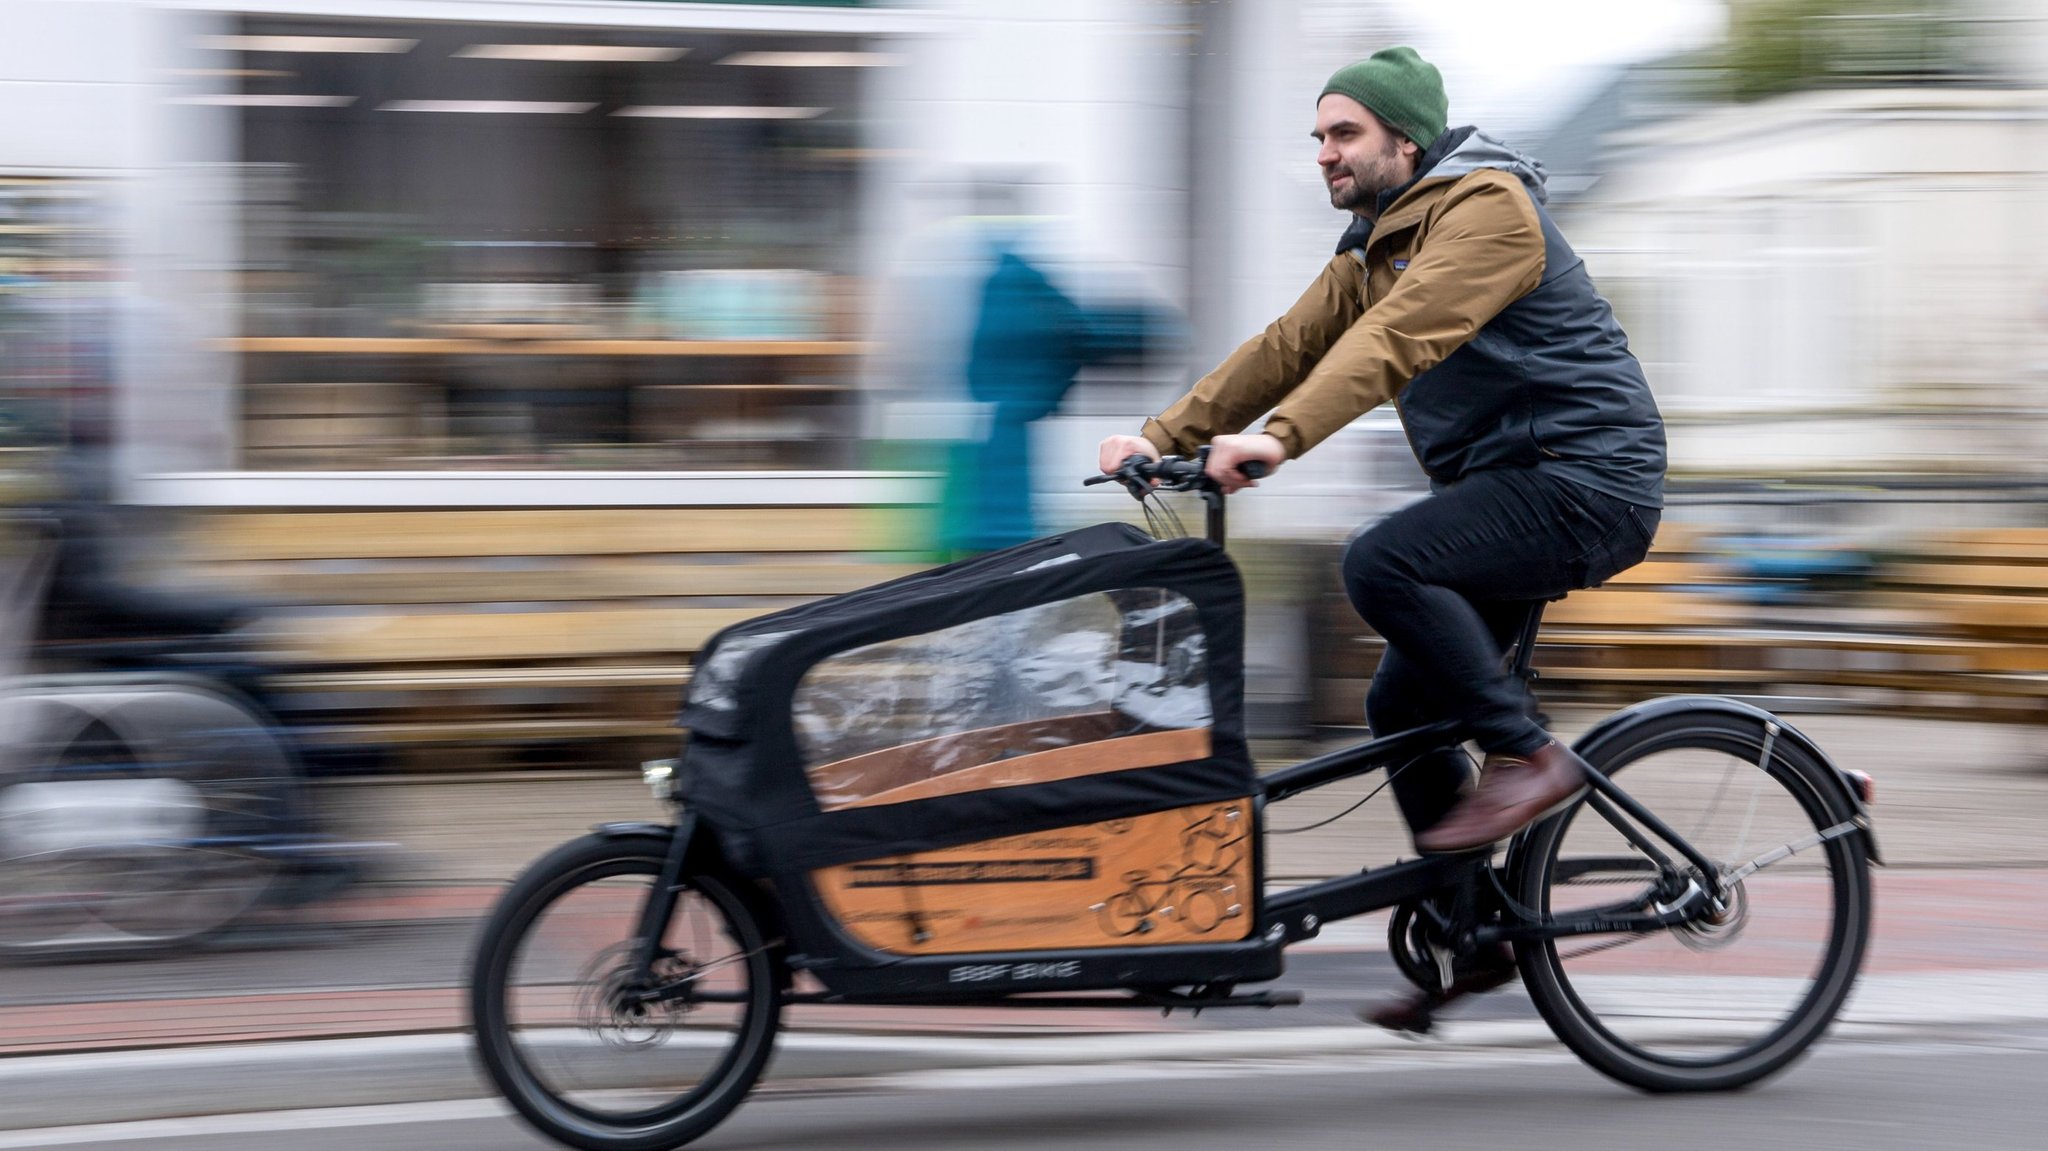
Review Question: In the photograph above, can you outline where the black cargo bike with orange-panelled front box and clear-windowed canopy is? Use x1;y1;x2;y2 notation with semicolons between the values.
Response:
471;457;1876;1151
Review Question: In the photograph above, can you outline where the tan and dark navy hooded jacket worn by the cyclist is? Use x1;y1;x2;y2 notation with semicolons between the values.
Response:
1145;127;1665;508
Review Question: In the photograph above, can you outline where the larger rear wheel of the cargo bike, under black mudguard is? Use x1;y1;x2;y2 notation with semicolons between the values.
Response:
1513;713;1872;1092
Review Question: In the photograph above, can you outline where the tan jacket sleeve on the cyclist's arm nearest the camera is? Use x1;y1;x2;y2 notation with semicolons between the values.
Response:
1261;172;1544;459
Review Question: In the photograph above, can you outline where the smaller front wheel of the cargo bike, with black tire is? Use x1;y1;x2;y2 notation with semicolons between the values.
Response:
469;834;786;1151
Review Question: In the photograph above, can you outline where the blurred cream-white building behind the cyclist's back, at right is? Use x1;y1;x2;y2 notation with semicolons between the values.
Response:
1569;86;2048;479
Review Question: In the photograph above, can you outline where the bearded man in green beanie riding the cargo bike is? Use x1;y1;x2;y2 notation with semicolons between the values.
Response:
1100;47;1665;1022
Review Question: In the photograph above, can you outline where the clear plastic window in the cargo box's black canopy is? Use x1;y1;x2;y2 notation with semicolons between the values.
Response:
791;588;1212;807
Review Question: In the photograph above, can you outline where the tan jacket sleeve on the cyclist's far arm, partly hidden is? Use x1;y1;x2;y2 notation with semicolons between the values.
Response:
1143;252;1366;455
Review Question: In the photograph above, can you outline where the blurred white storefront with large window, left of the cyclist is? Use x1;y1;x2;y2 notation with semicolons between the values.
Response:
0;0;1200;506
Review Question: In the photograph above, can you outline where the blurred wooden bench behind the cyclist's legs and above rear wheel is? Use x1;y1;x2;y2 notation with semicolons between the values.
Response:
1317;524;2048;723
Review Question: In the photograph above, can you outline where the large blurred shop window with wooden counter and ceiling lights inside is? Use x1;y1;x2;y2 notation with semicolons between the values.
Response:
220;16;893;471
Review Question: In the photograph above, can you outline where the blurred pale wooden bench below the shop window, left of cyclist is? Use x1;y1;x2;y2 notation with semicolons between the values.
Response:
180;508;922;770
